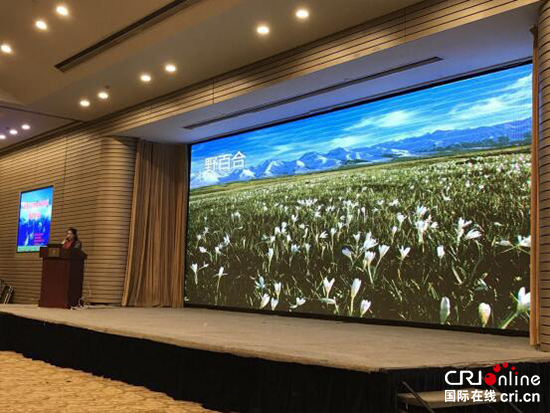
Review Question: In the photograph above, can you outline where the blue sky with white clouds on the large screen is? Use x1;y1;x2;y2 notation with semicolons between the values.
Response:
191;65;532;173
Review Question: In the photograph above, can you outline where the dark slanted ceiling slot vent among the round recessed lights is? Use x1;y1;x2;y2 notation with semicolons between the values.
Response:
55;0;199;72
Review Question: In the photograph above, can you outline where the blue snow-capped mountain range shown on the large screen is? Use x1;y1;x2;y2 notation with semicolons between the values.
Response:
191;118;531;189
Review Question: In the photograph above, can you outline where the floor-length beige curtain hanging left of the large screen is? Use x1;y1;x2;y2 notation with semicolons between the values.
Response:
122;140;187;307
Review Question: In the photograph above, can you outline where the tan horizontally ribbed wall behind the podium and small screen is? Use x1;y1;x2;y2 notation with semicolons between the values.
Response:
0;135;136;304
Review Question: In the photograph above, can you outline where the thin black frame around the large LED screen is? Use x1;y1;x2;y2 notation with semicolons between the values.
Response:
182;57;533;337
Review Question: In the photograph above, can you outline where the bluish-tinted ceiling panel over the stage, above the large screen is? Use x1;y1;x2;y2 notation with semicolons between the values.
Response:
119;4;538;143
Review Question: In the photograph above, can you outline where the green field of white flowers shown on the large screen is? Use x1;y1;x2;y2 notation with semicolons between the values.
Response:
185;146;531;330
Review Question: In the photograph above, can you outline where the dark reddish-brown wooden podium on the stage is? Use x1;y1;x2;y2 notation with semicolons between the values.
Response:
38;245;88;308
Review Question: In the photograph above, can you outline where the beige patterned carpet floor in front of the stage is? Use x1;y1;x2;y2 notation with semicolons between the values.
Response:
0;351;218;413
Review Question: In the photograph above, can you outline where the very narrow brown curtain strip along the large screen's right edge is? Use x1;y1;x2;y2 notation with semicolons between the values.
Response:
529;27;540;346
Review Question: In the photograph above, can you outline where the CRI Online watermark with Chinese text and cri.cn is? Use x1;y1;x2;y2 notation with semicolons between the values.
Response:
445;363;540;403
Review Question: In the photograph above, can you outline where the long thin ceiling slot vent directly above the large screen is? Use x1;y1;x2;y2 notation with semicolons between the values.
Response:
182;56;443;130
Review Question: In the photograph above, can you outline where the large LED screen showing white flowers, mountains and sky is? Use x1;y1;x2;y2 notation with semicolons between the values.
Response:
185;65;532;330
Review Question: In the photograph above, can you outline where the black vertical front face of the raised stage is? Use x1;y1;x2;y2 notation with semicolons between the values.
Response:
0;313;550;413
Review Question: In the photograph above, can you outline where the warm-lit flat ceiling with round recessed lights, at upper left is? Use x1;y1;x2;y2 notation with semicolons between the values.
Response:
0;0;424;148
